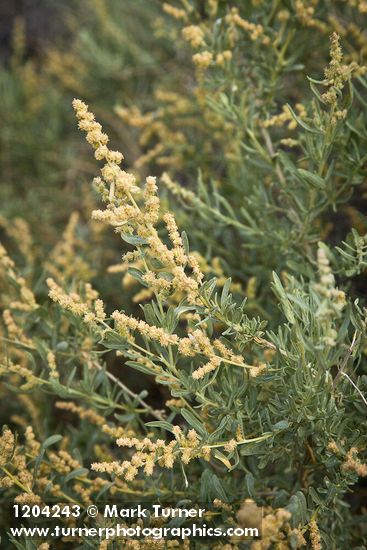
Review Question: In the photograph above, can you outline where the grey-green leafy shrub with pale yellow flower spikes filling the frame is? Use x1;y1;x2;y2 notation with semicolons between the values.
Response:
0;0;367;550
